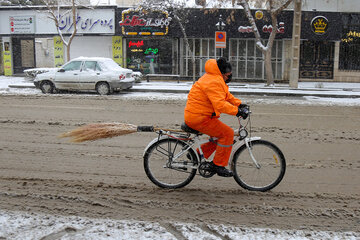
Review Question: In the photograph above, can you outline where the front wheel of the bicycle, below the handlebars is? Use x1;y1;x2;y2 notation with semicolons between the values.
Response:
232;140;286;192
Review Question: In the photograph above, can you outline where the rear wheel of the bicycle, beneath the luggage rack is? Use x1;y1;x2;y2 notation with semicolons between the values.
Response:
144;138;197;188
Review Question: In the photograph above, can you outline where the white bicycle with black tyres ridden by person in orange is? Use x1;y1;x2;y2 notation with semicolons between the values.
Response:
143;108;286;192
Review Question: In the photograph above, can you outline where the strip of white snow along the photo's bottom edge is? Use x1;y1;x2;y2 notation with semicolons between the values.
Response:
0;210;360;240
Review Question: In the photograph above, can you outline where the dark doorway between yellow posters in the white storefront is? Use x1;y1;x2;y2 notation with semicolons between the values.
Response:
12;38;36;74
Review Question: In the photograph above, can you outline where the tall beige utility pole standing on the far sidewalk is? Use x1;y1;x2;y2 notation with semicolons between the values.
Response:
289;0;301;88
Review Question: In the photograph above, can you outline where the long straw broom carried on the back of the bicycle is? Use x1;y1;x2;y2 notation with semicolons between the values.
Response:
59;122;182;142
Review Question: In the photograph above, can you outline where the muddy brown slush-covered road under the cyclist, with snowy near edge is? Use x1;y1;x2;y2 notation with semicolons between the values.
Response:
0;77;360;239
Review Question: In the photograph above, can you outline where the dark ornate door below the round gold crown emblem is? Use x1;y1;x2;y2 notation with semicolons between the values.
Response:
299;41;335;79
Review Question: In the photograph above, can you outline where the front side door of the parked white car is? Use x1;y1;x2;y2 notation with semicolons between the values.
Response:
55;61;82;90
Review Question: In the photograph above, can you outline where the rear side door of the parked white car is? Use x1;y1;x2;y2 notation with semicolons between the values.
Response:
79;60;101;90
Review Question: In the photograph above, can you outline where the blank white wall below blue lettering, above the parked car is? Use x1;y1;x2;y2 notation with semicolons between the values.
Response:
68;36;112;58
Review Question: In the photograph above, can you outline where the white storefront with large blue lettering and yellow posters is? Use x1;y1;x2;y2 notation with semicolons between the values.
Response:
0;6;115;75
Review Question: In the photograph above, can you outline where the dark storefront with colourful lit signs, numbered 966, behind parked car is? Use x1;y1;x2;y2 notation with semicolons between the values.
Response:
115;8;178;74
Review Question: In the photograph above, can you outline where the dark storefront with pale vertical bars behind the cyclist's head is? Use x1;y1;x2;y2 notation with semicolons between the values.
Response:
180;9;292;80
